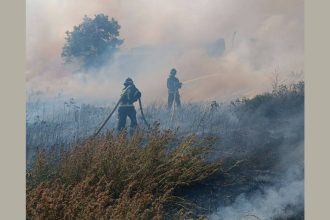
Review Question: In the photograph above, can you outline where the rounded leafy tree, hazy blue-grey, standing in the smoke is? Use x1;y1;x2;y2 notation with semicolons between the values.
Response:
62;14;123;69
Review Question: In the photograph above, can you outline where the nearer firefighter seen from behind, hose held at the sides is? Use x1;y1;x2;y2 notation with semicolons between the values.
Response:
117;78;141;135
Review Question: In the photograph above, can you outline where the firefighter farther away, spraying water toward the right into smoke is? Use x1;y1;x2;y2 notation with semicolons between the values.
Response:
167;68;182;109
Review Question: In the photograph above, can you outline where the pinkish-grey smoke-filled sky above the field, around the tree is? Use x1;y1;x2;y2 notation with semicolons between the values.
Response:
26;0;304;102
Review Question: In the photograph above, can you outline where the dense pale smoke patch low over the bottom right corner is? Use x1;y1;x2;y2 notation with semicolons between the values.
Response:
210;180;304;220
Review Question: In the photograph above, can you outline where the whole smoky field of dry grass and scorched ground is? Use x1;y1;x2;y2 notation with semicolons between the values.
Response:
26;82;304;219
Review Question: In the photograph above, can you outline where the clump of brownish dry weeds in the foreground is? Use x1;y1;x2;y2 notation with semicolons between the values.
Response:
27;128;222;219
